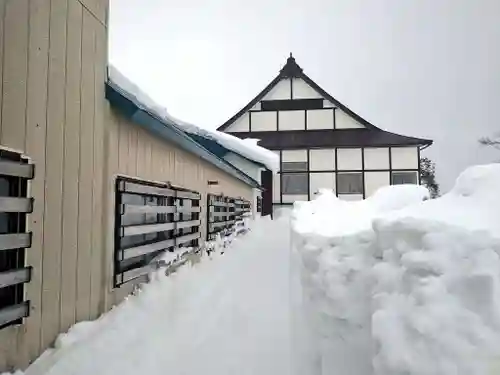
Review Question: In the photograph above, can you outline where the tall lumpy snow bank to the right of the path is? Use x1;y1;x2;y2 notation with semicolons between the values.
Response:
292;164;500;375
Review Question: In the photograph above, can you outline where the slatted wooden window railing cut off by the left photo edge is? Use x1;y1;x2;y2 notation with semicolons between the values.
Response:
0;150;34;328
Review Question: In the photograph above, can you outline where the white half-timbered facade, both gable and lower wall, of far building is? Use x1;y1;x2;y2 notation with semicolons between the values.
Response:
224;71;419;204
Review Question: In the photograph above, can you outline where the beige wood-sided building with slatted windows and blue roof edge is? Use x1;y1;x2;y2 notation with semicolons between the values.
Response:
0;0;258;372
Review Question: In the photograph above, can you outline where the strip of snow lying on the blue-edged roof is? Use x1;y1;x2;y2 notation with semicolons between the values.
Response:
108;66;279;172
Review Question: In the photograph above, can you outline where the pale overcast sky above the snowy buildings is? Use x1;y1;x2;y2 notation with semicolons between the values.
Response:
110;0;500;190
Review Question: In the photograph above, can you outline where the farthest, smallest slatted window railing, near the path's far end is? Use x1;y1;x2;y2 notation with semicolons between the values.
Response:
207;194;251;241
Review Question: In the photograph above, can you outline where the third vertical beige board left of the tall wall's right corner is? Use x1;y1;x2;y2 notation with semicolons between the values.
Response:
41;0;68;348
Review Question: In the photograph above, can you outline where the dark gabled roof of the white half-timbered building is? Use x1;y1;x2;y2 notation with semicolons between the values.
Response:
217;54;432;147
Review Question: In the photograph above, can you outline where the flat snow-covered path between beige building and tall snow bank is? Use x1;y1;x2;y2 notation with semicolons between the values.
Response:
26;218;291;375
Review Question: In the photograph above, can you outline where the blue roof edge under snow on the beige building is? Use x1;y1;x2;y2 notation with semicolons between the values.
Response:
106;80;261;188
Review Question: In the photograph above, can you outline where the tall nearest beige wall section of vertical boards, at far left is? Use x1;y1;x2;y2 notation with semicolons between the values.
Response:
0;0;108;372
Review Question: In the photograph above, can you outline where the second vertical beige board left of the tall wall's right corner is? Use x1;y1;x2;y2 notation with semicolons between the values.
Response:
61;0;82;331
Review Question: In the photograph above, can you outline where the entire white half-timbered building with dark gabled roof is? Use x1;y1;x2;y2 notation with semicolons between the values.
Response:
218;55;432;205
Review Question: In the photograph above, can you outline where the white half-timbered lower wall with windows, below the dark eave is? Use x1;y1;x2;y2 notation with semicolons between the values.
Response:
273;147;419;204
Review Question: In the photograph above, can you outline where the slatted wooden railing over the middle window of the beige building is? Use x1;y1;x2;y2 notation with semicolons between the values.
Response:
115;177;201;286
